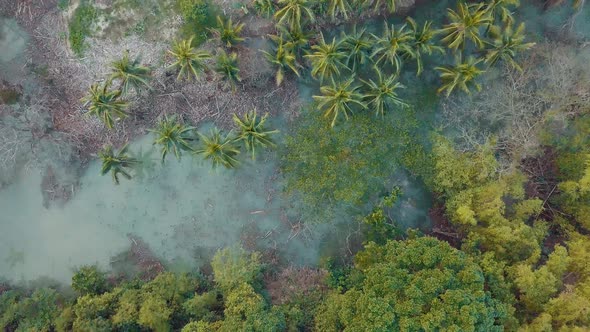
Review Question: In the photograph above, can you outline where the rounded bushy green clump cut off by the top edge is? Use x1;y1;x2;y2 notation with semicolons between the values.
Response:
178;0;221;46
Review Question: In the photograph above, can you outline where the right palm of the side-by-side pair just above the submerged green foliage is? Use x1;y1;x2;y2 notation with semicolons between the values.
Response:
361;67;408;116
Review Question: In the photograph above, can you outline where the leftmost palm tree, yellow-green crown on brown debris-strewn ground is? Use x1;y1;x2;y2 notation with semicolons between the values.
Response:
82;80;129;128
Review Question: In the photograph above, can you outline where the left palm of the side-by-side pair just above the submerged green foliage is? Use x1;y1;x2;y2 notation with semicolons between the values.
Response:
313;77;367;127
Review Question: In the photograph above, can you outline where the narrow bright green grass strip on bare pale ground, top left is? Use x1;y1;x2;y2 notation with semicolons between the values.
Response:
68;1;97;56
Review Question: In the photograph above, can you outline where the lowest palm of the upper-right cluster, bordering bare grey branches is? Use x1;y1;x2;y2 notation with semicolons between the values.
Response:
435;57;484;97
